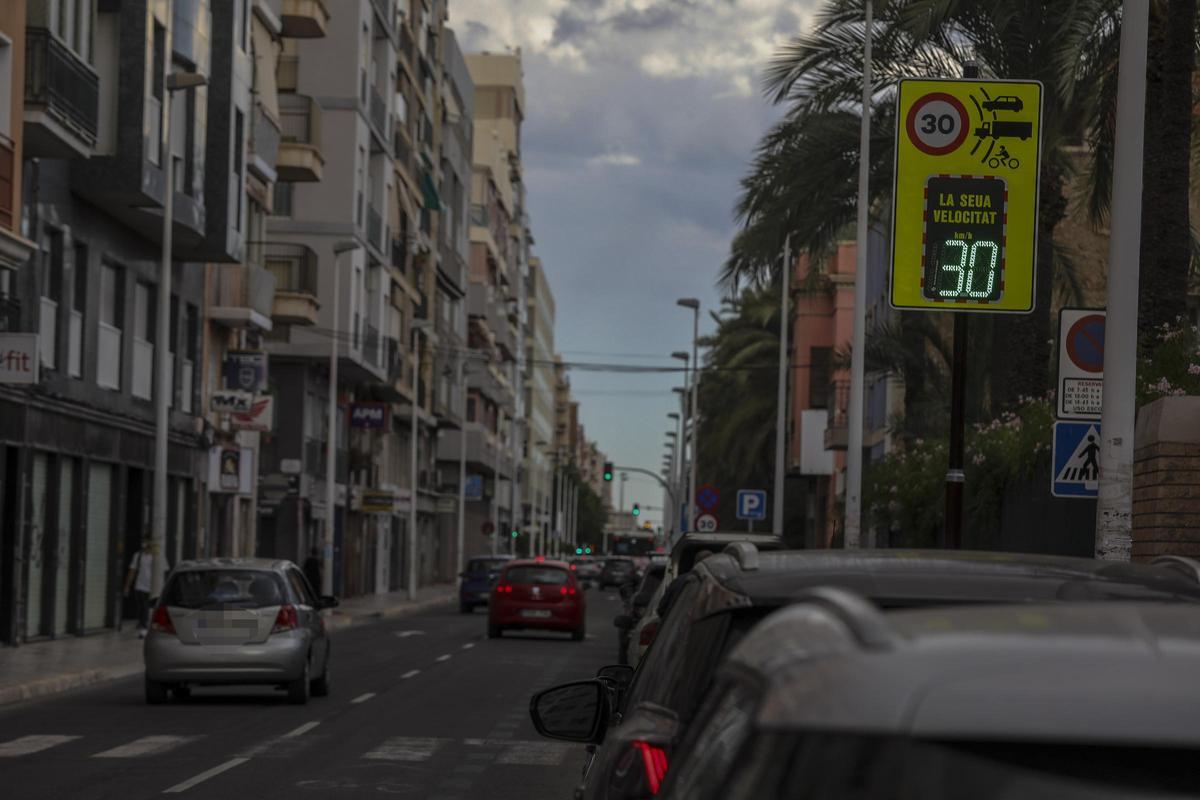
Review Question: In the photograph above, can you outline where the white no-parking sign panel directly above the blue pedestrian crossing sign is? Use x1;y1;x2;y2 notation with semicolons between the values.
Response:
1056;308;1105;420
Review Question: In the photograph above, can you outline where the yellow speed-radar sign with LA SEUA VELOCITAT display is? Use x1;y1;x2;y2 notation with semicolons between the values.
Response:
892;79;1042;313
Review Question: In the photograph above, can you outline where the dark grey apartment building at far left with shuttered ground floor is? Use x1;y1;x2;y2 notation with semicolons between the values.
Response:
0;0;258;642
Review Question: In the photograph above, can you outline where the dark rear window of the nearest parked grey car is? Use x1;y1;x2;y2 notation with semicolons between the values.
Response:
724;732;1200;800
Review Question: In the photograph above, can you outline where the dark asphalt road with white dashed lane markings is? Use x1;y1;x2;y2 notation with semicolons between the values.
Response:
0;589;620;800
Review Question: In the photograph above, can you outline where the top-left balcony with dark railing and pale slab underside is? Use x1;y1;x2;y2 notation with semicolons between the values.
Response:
24;28;100;158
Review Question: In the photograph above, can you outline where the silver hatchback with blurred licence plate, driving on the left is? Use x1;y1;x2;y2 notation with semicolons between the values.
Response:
143;558;337;703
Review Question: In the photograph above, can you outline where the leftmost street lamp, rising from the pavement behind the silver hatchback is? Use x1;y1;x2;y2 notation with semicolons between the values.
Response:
150;72;207;597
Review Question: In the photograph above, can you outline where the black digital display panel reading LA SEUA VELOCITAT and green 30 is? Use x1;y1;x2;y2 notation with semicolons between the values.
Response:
920;175;1007;303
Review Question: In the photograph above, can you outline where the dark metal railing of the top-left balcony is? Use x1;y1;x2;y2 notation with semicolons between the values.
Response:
25;28;100;148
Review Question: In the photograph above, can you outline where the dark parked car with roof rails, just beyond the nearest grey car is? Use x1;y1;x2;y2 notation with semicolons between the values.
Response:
535;542;1200;800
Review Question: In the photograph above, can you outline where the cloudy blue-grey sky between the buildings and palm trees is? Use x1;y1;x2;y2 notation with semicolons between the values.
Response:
450;0;816;532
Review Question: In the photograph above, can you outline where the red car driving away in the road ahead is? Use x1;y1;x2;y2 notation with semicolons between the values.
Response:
487;559;587;642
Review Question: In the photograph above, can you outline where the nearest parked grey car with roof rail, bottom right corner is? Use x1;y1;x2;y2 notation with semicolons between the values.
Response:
657;599;1200;800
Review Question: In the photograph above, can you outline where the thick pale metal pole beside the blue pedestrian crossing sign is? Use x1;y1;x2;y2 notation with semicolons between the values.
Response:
1096;0;1147;561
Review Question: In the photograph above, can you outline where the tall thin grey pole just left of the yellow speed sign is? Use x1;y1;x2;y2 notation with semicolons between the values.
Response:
844;0;875;548
